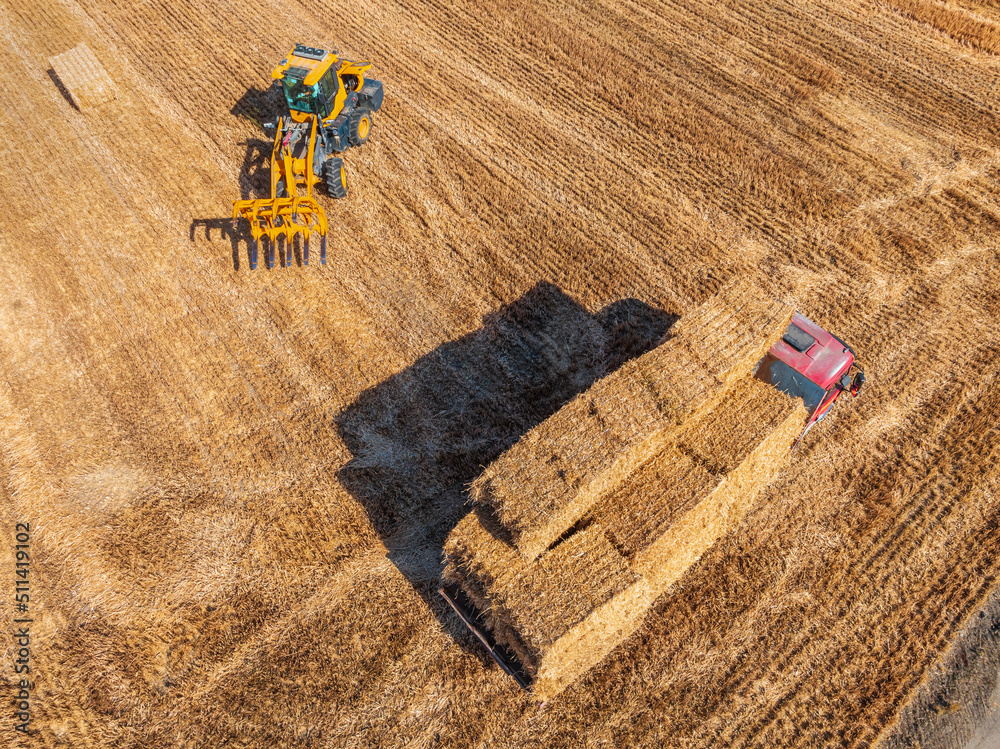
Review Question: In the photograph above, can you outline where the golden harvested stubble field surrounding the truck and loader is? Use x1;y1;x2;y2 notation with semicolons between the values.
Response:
0;0;1000;748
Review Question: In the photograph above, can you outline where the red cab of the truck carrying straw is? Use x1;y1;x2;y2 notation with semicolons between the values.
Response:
755;312;865;449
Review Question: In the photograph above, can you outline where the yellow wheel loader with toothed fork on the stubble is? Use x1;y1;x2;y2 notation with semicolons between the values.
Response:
233;44;382;269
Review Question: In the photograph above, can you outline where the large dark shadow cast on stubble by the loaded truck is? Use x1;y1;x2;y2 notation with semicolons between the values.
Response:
337;283;677;641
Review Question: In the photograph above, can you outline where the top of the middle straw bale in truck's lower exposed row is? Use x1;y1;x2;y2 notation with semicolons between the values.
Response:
594;447;721;558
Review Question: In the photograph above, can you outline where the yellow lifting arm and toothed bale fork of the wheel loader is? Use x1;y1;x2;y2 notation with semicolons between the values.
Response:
233;117;327;269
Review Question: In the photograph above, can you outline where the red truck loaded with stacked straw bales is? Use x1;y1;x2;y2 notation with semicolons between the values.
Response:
441;283;864;699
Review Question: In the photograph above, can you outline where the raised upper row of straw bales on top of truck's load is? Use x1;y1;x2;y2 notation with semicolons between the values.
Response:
471;283;793;559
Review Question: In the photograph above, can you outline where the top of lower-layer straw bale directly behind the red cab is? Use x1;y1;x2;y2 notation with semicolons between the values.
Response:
679;377;796;474
